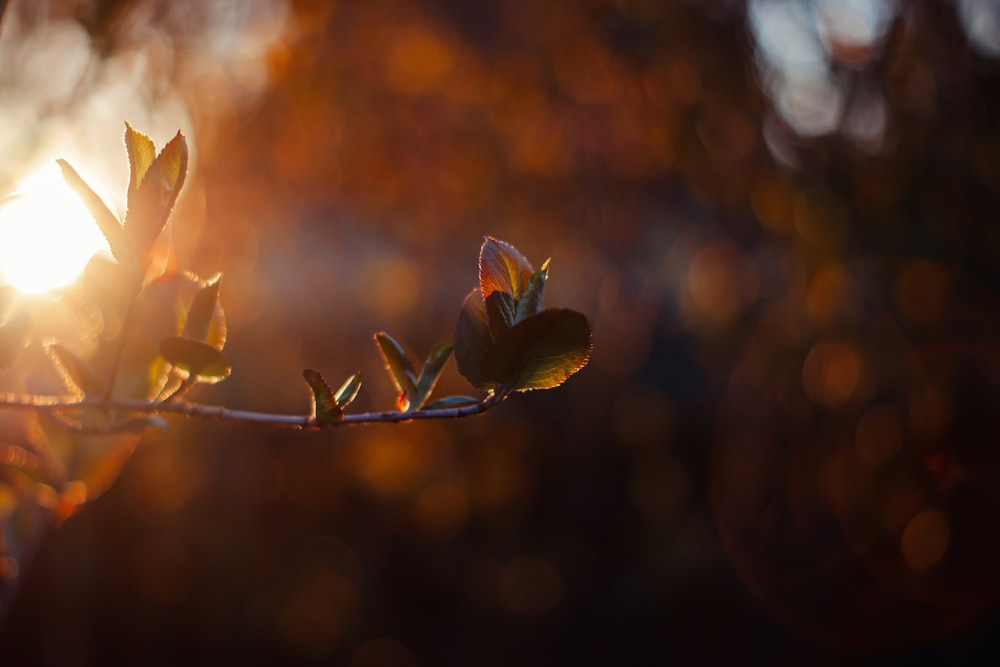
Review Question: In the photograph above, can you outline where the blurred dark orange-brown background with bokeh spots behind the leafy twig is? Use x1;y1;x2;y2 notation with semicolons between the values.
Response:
0;0;1000;666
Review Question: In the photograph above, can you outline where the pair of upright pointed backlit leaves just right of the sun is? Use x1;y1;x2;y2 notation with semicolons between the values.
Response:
125;126;188;266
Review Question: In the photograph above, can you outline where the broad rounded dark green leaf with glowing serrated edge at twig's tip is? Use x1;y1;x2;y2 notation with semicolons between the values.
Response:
479;309;593;391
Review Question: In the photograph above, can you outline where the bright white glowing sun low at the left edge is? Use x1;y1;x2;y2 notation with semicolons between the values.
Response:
0;162;108;294
